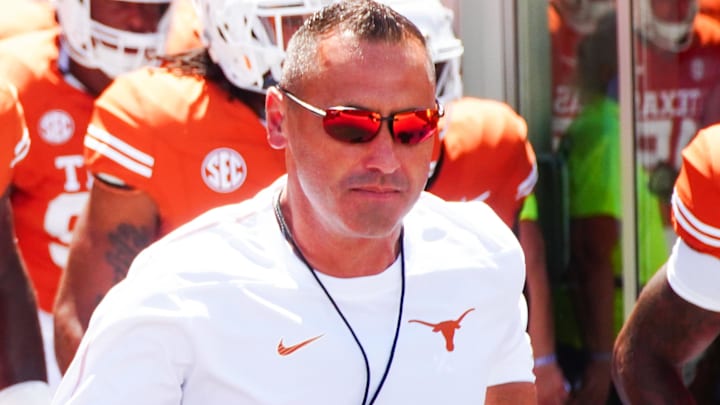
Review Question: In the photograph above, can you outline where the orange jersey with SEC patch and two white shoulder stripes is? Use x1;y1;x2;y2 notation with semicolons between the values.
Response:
85;68;285;234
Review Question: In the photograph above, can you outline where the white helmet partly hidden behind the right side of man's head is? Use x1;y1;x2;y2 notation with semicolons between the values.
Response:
379;0;464;104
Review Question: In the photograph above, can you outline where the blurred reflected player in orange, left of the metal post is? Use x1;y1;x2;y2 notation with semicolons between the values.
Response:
548;0;615;149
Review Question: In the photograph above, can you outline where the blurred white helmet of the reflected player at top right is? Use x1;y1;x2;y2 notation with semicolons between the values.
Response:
633;0;698;52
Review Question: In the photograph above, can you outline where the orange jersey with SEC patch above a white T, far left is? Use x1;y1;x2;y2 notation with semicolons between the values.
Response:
0;29;93;311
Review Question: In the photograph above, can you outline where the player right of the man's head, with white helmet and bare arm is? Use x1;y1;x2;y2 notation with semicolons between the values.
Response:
381;0;568;405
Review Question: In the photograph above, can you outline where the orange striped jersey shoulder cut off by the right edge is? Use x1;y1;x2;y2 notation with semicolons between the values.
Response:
672;124;720;258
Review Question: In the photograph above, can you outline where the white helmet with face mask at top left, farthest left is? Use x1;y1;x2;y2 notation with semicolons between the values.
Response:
53;0;172;78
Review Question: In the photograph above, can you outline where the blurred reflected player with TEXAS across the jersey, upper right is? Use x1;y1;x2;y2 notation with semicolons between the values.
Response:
633;0;720;213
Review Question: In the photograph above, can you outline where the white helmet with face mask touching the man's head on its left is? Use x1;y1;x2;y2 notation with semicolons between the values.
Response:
193;0;333;93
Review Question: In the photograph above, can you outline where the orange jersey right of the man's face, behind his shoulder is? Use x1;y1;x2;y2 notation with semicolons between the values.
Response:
428;97;537;227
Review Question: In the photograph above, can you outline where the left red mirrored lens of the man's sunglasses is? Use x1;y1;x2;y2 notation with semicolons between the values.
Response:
323;109;382;143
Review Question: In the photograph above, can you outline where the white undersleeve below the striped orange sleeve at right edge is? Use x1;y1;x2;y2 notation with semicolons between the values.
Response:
667;238;720;312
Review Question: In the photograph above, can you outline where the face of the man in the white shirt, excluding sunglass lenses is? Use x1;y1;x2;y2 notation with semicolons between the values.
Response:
283;35;435;238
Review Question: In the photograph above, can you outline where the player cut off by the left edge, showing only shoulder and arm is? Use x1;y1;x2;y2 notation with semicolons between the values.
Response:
0;81;50;405
